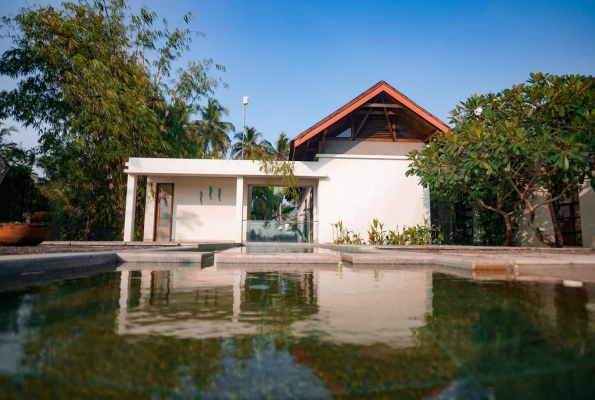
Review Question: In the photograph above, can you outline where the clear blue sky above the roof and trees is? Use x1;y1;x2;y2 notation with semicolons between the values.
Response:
0;0;595;150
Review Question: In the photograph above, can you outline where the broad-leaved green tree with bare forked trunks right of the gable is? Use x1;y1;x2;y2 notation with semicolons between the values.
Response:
407;73;595;245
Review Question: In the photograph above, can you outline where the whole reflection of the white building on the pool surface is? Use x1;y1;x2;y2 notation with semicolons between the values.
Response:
117;265;432;348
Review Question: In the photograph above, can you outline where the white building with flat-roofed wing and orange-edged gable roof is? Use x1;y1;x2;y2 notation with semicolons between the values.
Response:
124;81;595;246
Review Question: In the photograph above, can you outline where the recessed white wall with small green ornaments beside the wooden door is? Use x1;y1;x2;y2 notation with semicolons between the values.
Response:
144;176;237;242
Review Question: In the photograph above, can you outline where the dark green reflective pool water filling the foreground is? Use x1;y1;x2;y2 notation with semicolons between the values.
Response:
0;264;595;399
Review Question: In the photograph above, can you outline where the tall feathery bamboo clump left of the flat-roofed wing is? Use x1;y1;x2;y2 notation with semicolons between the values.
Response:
0;0;224;239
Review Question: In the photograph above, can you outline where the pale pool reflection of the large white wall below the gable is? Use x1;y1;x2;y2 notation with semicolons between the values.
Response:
293;268;433;348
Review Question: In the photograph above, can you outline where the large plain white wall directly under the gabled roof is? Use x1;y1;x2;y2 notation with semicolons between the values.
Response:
317;155;430;243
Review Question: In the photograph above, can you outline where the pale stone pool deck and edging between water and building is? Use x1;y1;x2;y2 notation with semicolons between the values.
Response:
0;242;595;282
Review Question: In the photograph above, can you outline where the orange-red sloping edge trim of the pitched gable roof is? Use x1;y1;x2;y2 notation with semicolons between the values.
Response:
292;81;450;148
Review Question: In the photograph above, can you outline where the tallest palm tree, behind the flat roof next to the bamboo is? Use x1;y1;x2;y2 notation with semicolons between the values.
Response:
189;98;235;158
